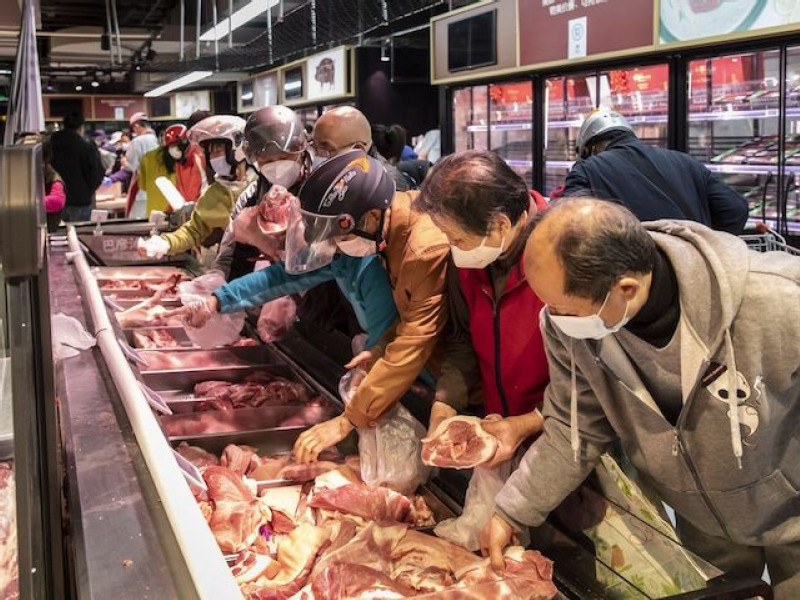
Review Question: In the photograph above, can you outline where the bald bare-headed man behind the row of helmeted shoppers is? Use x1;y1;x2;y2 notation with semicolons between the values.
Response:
312;106;410;192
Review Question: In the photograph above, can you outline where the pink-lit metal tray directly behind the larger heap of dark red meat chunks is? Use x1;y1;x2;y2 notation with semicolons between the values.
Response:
135;346;277;372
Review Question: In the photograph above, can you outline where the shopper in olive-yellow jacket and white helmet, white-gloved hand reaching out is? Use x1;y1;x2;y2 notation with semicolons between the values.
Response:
139;115;246;259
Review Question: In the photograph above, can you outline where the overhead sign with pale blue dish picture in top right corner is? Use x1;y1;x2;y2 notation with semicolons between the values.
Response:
659;0;800;44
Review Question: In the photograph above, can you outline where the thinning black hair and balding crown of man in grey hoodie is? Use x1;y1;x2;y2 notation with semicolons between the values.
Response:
534;198;658;303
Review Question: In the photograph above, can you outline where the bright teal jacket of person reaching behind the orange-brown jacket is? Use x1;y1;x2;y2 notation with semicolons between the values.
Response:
213;254;398;349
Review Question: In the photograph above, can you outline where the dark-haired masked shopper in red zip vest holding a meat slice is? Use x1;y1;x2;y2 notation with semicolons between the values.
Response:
414;150;549;465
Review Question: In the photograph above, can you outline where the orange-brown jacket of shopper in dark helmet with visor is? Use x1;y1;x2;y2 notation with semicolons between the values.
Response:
346;192;450;427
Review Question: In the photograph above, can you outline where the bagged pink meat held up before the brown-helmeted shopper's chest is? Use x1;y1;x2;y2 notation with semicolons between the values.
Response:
233;186;294;260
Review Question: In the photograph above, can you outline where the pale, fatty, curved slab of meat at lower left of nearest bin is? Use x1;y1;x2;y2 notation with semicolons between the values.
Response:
242;523;330;600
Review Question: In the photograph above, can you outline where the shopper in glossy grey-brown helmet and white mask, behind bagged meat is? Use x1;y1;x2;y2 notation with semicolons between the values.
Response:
213;105;311;281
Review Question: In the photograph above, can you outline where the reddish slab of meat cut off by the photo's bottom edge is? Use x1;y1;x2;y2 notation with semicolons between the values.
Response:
311;564;416;600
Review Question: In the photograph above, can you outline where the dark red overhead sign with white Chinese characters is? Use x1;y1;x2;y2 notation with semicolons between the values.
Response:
518;0;655;66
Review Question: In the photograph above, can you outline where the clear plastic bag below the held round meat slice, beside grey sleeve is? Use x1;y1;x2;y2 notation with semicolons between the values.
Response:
433;461;527;552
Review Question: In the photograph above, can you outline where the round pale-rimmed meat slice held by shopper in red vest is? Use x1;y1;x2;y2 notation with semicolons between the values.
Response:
422;416;497;469
